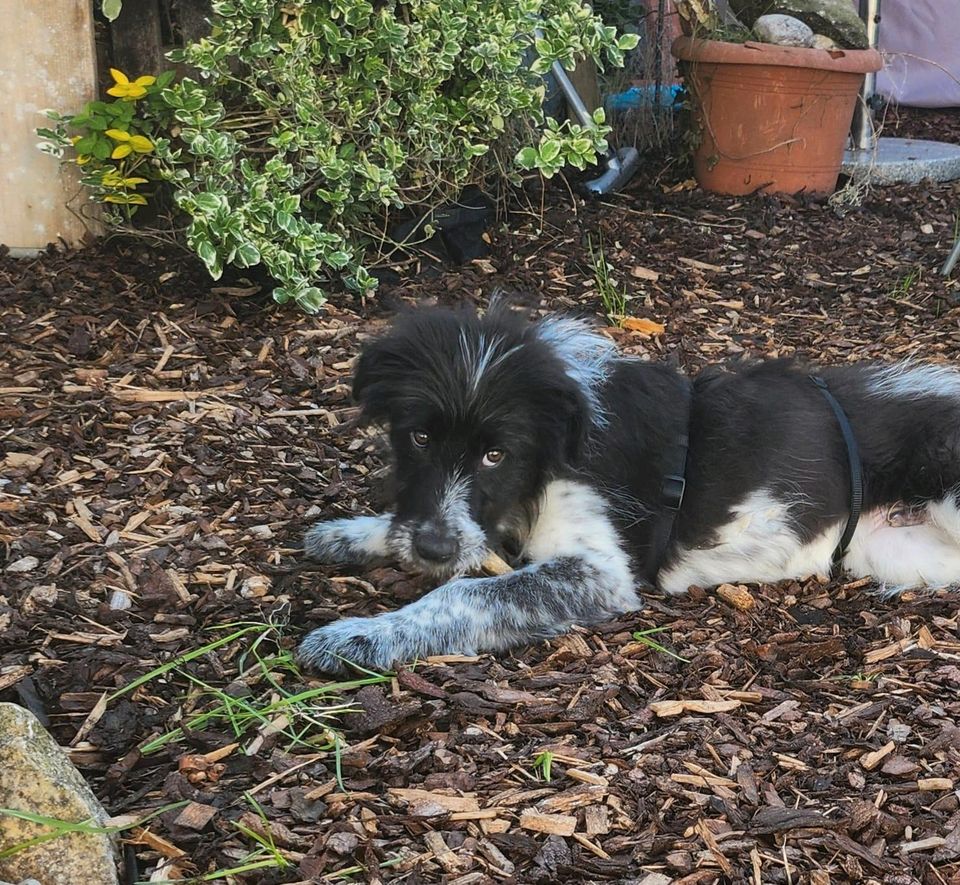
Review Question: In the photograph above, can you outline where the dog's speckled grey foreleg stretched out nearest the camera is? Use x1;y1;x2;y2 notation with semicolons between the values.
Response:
298;556;640;673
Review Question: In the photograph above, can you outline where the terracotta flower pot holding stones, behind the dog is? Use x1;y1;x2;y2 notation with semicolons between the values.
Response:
671;37;883;194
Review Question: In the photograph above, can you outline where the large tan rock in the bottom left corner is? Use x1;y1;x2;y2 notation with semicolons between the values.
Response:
0;704;118;885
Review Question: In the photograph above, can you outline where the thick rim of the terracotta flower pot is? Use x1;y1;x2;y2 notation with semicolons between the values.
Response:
670;35;883;74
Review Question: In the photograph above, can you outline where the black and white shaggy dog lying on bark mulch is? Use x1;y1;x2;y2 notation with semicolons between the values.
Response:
299;309;960;671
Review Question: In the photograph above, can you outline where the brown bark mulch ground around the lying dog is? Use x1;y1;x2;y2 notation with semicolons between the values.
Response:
0;113;960;885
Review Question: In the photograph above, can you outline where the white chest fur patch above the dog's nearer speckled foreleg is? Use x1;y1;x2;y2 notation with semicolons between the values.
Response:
523;479;639;611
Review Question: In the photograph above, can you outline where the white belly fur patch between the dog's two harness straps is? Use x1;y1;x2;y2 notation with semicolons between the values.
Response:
658;490;843;594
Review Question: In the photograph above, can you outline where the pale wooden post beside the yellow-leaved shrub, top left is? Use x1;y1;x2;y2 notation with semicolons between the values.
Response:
0;0;99;255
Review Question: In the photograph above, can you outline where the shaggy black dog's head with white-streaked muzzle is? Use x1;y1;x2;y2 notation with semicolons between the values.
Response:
354;309;608;573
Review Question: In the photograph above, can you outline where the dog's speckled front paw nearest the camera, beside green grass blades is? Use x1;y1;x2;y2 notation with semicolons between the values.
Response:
297;616;399;674
